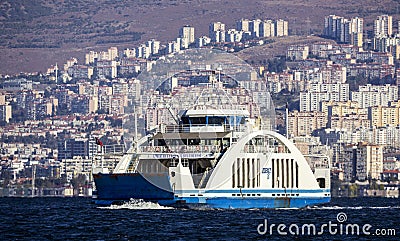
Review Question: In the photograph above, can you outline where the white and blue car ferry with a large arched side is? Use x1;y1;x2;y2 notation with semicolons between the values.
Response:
93;70;331;209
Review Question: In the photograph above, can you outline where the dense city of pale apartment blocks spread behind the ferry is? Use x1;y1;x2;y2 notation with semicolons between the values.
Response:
0;5;400;200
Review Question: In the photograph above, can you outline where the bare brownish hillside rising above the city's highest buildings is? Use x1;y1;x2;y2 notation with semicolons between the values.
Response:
0;0;400;74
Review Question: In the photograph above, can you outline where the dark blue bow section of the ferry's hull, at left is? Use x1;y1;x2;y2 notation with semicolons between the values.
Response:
93;173;174;203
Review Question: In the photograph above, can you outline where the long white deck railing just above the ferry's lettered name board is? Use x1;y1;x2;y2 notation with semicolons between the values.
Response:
139;145;221;153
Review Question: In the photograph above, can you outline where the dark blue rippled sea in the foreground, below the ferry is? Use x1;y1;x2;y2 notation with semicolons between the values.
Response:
0;198;400;240
